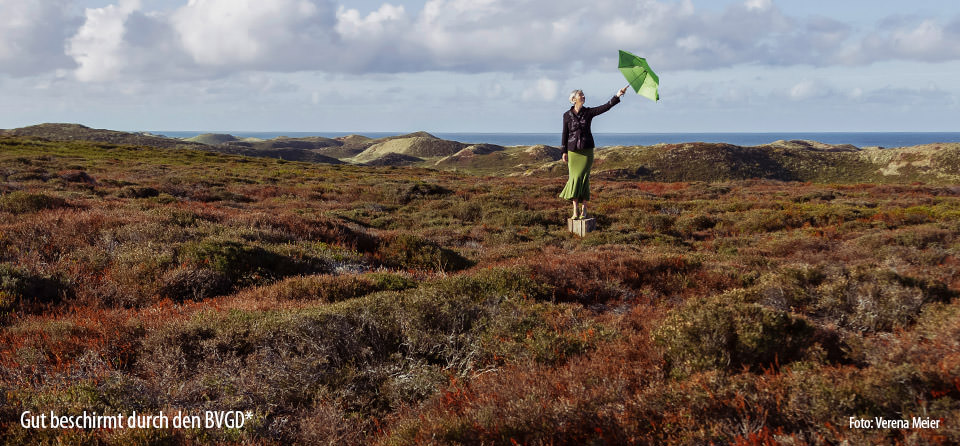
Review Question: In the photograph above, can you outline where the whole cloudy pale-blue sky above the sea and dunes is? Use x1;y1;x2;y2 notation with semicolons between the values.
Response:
0;0;960;133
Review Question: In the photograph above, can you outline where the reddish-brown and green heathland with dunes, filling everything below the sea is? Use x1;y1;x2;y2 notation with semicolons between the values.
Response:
0;125;960;445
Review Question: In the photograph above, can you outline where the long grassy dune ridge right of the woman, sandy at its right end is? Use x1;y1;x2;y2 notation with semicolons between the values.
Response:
588;141;960;184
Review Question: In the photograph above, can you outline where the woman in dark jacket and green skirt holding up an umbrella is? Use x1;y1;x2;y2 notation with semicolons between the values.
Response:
560;85;629;219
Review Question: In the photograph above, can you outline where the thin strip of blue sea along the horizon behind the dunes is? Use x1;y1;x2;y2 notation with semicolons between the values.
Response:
151;131;960;147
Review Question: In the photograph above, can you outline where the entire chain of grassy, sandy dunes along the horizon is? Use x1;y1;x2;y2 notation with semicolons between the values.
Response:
7;124;960;184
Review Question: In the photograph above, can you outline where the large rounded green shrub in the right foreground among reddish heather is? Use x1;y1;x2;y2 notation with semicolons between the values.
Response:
654;293;814;377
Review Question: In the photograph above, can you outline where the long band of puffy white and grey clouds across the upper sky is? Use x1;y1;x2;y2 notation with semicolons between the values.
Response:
0;0;960;83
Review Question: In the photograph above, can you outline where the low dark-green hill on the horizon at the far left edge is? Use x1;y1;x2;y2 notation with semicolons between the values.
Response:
0;124;206;149
